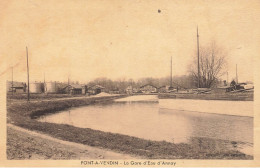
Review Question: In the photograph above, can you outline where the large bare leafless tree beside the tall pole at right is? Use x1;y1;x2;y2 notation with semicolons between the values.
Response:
190;43;227;88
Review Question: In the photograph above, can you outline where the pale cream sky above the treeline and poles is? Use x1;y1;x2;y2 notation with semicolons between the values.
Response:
0;0;260;82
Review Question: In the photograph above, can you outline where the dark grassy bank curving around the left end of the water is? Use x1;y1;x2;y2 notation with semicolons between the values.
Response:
7;95;253;160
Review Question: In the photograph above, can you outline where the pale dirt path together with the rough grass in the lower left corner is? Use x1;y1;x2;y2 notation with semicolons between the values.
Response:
7;124;136;160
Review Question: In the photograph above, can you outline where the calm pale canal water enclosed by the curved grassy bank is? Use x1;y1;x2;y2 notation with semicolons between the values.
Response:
39;96;253;155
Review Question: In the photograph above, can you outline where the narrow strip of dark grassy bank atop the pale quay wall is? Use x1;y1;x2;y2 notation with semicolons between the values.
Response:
158;92;254;101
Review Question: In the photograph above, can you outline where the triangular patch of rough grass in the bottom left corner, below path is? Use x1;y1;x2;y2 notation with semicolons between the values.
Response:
6;128;77;160
